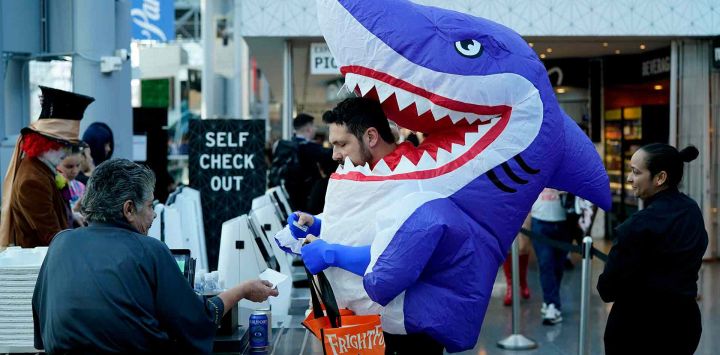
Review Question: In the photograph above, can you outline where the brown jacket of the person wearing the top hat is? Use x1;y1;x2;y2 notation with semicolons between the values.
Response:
7;158;68;248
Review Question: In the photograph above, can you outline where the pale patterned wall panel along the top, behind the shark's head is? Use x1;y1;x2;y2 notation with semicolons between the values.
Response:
241;0;720;37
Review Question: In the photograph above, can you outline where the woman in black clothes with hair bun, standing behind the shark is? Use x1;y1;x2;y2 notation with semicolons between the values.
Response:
597;144;708;354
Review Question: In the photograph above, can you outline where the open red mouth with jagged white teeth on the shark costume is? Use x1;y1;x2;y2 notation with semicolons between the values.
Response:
331;66;512;181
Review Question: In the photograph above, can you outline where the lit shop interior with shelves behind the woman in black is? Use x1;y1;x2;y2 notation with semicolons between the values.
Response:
603;47;670;237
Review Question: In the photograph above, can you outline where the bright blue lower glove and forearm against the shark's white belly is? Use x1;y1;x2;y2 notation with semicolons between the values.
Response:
301;239;370;276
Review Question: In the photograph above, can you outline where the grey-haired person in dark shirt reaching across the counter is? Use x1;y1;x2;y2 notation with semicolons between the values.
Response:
32;159;278;354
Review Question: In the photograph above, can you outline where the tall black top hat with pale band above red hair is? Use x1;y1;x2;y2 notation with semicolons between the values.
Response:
20;86;95;145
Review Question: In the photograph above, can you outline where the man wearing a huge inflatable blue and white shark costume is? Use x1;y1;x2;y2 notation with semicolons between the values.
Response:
276;0;610;352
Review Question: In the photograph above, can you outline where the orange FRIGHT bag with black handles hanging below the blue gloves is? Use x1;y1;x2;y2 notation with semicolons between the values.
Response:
302;269;385;355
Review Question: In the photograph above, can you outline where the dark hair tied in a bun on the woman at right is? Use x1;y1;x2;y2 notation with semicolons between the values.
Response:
640;143;700;188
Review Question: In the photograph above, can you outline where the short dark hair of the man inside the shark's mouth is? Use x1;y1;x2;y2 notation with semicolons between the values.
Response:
323;97;395;143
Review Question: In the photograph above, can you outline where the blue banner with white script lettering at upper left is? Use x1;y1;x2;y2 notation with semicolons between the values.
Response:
130;0;175;42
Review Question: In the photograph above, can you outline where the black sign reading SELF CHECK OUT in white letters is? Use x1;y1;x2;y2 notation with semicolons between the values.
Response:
189;119;267;268
